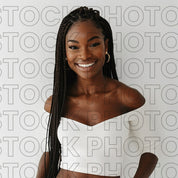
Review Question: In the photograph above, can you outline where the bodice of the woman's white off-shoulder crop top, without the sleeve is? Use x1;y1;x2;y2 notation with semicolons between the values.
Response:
57;105;145;176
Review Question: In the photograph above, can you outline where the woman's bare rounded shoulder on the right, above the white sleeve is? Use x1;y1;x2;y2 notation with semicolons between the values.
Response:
107;79;145;110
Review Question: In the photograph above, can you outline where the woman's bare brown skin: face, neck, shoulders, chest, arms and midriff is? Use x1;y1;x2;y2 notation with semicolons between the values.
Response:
37;21;157;178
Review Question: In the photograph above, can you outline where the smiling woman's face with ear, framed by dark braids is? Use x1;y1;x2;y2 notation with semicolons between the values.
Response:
66;21;108;79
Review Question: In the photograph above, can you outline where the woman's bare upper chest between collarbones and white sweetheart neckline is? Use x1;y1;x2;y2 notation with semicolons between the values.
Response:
62;96;127;125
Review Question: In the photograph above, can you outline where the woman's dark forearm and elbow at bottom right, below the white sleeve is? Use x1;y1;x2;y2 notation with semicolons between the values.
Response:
134;153;158;178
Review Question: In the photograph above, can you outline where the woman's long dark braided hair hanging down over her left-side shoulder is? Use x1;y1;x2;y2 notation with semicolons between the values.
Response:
45;6;118;178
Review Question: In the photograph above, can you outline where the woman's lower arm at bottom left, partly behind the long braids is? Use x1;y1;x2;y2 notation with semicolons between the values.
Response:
36;152;49;178
